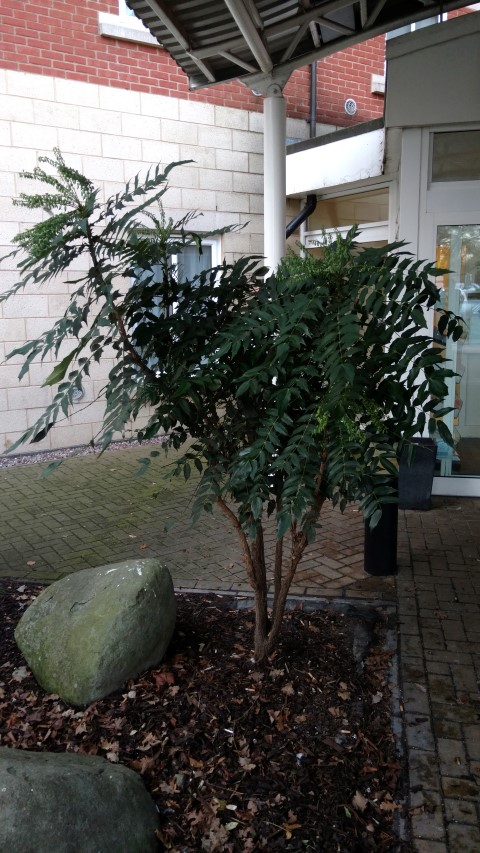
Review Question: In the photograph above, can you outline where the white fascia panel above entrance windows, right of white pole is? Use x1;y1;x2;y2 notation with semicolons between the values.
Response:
287;128;385;196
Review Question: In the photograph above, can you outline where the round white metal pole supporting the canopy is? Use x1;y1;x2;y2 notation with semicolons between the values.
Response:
263;83;287;272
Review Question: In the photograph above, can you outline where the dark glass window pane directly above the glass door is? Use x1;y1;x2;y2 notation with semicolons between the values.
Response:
432;130;480;181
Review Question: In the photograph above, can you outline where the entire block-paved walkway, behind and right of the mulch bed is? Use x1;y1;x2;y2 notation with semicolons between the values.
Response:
0;442;480;853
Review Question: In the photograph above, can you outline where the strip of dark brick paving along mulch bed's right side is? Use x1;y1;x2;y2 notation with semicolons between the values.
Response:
397;498;480;853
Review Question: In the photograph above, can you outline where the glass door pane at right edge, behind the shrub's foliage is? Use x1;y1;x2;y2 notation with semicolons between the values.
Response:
433;225;480;477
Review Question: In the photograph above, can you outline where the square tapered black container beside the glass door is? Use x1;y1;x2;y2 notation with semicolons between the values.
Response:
398;438;437;509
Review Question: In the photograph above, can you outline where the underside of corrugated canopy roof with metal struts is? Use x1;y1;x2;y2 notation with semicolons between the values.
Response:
127;0;466;89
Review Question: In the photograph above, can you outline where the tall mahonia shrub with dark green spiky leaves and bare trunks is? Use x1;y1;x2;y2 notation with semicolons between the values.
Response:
0;151;462;660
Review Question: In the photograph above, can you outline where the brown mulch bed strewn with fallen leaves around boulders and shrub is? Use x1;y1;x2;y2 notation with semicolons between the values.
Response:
0;581;410;853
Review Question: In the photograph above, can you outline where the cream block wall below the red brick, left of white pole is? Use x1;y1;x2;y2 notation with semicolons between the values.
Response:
0;69;308;453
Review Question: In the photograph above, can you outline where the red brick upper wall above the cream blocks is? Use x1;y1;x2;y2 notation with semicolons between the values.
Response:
0;0;468;126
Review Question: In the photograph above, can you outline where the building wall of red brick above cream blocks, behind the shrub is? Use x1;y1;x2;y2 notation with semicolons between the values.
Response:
0;0;390;453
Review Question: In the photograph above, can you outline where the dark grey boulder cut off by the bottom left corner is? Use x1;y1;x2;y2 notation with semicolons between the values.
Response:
0;747;158;853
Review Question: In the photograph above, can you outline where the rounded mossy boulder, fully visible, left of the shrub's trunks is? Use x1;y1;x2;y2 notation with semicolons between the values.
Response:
15;560;176;705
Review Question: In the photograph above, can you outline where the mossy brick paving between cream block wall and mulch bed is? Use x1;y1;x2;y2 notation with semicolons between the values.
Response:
0;448;395;600
